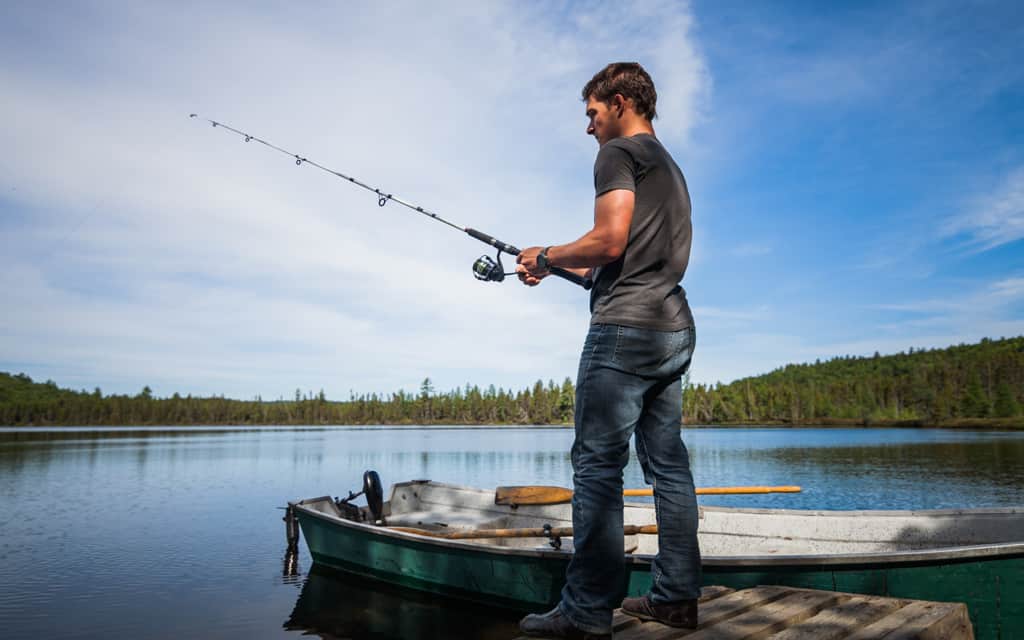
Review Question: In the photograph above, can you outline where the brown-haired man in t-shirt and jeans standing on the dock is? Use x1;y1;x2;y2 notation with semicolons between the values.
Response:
516;62;700;638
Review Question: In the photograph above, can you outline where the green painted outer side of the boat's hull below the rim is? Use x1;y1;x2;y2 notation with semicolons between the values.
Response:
295;506;1024;640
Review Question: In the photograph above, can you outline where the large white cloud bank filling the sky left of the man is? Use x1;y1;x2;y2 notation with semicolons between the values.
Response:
0;2;710;397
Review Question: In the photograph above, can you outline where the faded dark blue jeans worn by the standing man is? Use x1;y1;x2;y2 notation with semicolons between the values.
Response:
559;325;701;634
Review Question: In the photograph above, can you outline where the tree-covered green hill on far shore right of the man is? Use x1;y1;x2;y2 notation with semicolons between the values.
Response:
684;337;1024;426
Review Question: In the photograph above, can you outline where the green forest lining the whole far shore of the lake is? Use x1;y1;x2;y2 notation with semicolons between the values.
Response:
0;336;1024;428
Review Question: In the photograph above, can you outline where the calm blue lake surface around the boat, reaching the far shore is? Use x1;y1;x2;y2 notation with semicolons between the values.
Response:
0;427;1024;640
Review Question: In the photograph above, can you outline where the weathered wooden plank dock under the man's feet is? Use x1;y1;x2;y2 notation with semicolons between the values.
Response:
520;587;974;640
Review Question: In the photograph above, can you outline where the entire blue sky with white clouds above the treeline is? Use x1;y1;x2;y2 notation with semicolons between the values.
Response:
0;2;1024;398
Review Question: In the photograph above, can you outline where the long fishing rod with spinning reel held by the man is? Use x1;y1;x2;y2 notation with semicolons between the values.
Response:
188;114;594;290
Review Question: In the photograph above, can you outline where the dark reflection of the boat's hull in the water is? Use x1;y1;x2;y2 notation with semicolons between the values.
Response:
284;565;521;640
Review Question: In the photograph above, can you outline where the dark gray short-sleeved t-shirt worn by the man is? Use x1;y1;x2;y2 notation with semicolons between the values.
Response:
590;133;693;331
